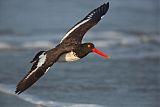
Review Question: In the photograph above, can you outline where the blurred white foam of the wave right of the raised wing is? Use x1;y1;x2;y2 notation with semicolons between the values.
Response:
84;31;160;47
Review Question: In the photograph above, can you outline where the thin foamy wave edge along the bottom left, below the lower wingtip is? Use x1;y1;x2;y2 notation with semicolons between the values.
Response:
0;84;103;107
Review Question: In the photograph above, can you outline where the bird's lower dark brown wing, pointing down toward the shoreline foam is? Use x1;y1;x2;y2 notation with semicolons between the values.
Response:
15;51;60;94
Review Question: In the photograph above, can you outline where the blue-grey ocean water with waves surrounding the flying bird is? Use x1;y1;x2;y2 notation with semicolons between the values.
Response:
0;0;160;107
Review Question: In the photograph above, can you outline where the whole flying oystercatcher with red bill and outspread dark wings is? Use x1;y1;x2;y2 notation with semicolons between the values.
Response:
15;2;110;94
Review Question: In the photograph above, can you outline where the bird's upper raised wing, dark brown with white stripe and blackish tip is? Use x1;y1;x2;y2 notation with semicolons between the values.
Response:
60;2;109;44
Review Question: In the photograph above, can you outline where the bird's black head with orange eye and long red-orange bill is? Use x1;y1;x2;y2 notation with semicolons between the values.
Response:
82;43;110;58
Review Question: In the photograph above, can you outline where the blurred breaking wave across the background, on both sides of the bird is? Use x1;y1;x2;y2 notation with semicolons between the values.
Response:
0;31;160;50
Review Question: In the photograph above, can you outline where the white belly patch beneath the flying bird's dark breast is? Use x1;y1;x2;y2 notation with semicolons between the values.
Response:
58;52;80;62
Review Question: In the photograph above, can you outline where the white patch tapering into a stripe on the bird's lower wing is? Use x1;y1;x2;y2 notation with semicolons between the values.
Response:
25;55;46;79
